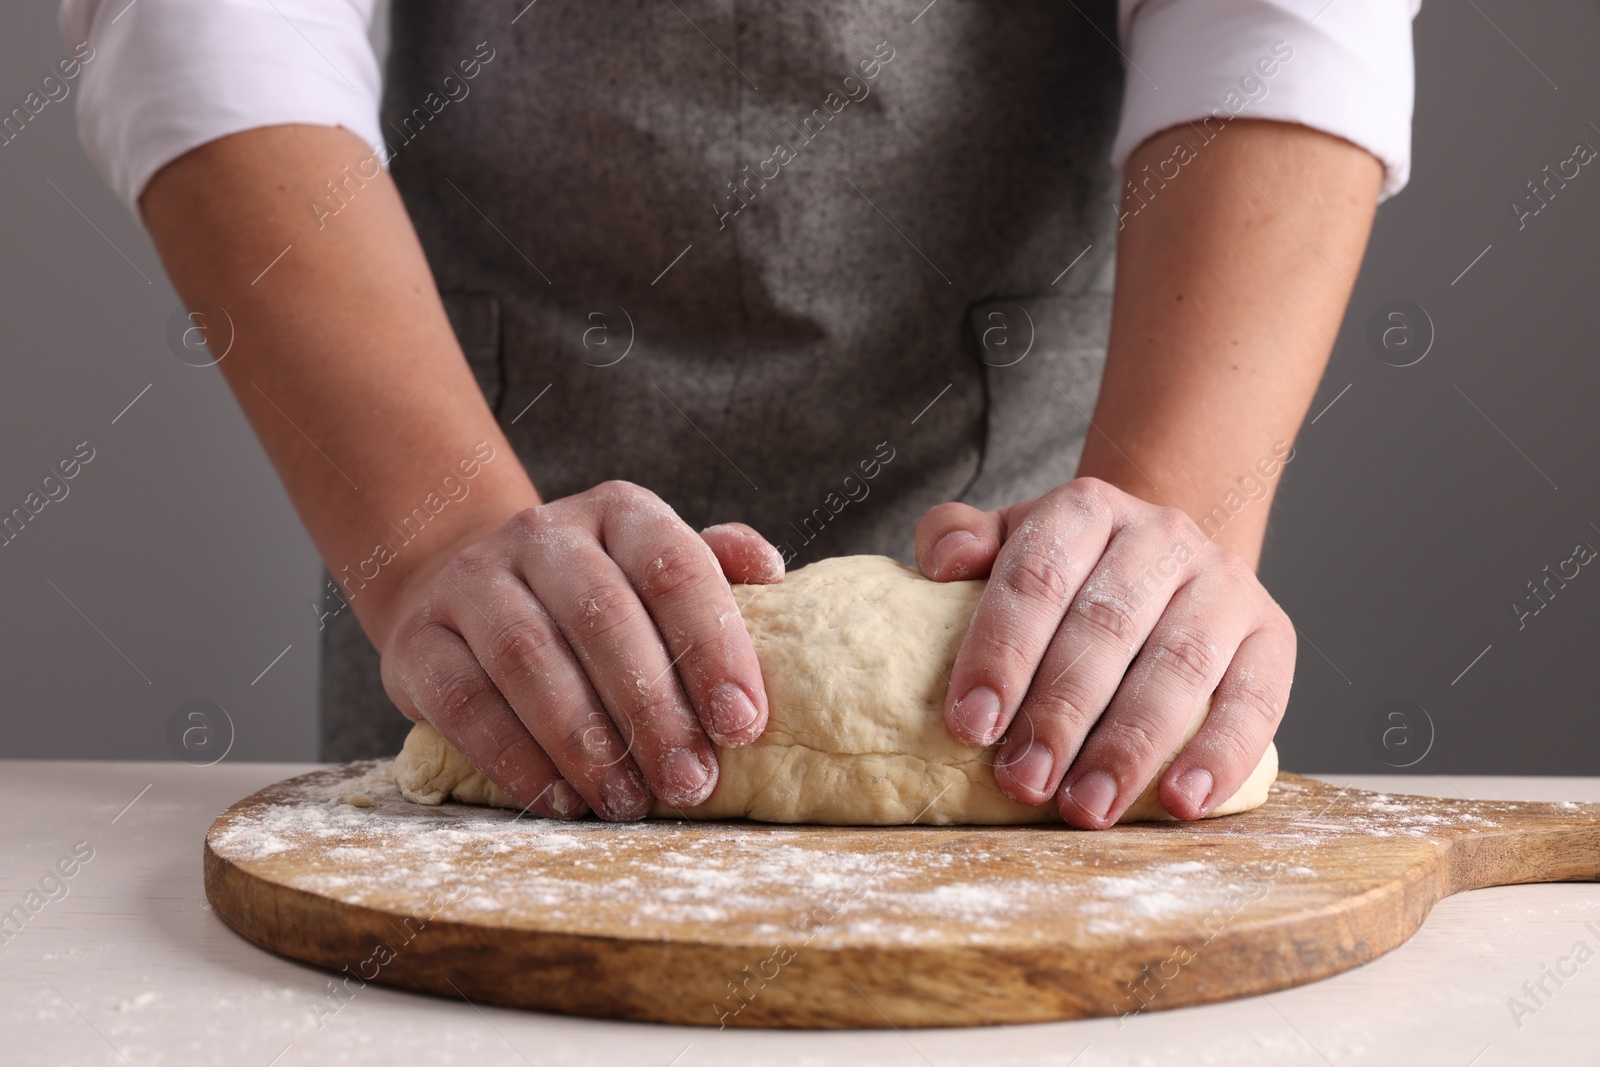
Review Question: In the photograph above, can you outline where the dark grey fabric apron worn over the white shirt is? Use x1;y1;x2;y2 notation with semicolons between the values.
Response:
322;0;1122;760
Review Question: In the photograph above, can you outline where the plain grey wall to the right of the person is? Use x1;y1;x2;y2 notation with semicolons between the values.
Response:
1262;0;1600;774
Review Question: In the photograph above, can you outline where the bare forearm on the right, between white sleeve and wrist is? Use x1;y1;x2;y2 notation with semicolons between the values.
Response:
1078;120;1382;565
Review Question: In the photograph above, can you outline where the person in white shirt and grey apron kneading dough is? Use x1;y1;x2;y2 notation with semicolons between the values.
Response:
62;0;1416;827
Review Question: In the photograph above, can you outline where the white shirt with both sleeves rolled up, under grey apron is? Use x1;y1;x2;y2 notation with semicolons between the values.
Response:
61;0;1422;214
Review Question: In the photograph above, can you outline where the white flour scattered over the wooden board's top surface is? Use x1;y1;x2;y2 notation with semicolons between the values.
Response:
208;760;1589;947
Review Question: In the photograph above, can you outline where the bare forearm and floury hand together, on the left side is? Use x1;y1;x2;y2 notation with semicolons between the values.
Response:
139;125;784;819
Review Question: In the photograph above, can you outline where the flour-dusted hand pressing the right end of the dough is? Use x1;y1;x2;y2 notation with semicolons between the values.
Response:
917;478;1294;829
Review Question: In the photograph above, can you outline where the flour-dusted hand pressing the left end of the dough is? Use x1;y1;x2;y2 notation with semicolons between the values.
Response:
382;482;784;819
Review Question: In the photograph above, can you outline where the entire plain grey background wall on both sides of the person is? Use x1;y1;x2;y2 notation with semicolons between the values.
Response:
0;0;1600;774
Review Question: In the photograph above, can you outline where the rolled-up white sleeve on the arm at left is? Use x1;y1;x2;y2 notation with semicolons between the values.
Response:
59;0;382;216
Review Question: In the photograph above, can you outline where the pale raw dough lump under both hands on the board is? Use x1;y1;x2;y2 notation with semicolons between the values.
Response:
394;555;1278;825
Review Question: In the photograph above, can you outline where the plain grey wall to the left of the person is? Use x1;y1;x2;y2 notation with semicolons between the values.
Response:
0;3;328;760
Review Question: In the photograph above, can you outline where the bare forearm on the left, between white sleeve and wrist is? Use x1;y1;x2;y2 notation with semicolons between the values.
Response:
141;126;539;646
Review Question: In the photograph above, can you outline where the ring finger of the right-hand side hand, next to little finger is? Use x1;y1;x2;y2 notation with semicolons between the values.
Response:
1056;563;1253;829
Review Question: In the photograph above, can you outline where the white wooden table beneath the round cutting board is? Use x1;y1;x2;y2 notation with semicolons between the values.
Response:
0;760;1600;1067
